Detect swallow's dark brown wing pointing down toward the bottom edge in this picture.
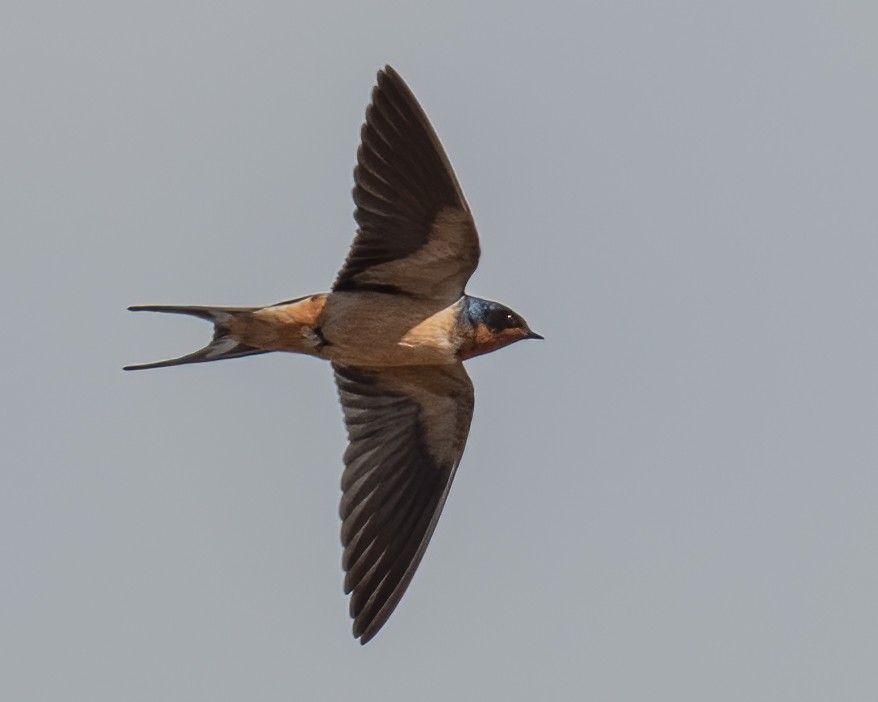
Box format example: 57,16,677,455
333,363,473,643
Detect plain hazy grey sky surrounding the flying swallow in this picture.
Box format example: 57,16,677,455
0,0,878,702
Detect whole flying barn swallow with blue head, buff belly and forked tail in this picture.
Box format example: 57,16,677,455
126,66,543,644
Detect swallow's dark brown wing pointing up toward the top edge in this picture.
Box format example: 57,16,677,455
333,66,479,302
